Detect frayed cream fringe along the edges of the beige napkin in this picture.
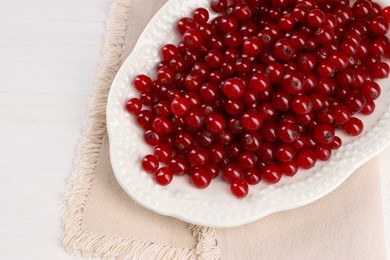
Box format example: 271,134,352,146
62,0,221,259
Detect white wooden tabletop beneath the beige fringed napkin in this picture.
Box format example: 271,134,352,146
0,0,390,260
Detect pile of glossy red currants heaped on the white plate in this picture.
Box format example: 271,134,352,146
126,0,390,198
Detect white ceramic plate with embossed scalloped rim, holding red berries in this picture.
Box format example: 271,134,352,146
107,0,390,227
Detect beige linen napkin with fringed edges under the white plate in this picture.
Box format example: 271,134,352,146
62,0,385,259
